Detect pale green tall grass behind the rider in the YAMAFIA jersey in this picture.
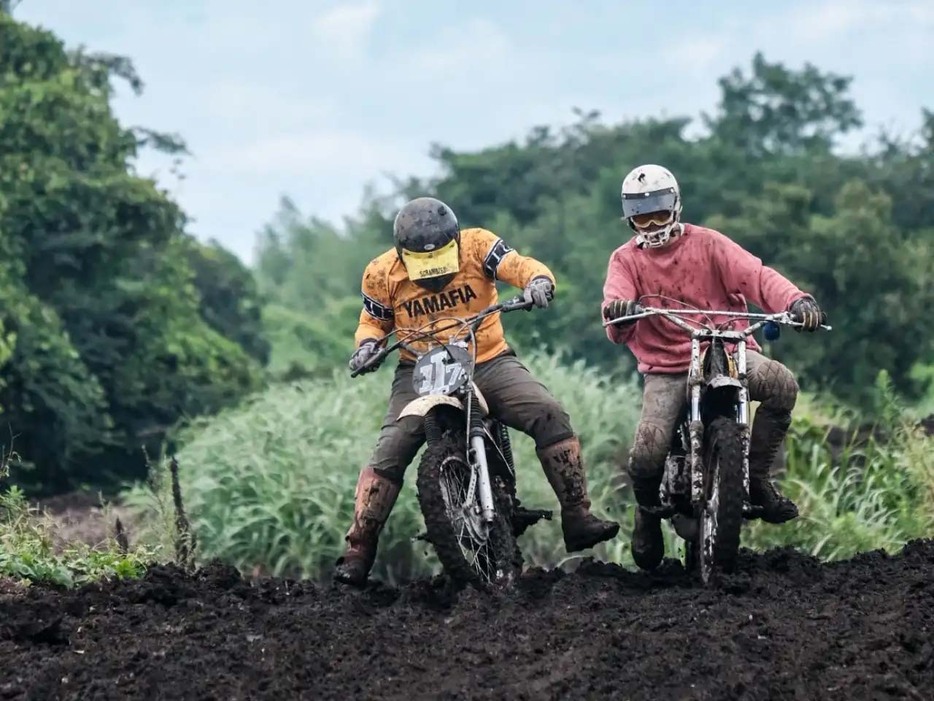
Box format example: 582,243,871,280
128,355,641,581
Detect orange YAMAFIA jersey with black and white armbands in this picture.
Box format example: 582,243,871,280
354,228,555,363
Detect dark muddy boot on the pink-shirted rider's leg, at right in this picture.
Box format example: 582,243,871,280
749,405,798,523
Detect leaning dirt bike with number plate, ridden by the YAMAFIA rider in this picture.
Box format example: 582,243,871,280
351,296,552,589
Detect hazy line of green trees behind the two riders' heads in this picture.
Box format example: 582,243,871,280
257,54,934,410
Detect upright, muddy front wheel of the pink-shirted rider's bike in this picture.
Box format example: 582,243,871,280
688,417,745,584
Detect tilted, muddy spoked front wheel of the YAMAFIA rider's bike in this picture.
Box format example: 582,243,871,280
417,433,522,589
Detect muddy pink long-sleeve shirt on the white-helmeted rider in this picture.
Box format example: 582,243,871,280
601,224,807,374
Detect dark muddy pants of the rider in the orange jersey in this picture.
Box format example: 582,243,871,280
369,351,574,483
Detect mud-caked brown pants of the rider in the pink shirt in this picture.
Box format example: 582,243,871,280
628,350,798,494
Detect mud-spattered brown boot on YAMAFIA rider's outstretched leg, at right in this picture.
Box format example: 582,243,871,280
536,436,619,552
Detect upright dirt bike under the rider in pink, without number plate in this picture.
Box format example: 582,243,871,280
604,304,831,584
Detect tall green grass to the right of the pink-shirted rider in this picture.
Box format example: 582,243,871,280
745,372,934,560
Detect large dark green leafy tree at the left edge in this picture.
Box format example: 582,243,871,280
0,15,260,491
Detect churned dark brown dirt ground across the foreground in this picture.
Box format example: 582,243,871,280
0,541,934,699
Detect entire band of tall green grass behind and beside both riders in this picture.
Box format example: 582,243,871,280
124,355,934,582
